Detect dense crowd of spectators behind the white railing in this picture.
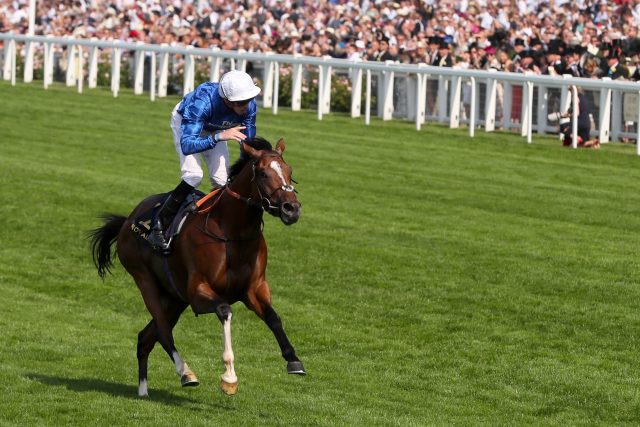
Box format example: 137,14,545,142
0,0,640,80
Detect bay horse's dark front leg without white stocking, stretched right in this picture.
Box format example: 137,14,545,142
244,281,306,375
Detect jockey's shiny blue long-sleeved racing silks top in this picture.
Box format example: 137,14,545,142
178,82,258,156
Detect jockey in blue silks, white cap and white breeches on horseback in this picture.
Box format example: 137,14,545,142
147,70,260,254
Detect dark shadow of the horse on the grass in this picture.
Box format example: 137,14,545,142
25,373,201,406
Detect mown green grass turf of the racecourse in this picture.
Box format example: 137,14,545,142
0,82,640,426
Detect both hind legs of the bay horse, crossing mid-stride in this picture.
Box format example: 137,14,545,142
136,272,198,396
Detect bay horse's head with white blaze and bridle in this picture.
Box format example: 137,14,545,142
243,138,301,225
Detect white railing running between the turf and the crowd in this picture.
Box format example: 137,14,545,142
0,33,640,155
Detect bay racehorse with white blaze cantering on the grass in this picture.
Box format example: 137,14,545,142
89,137,306,396
